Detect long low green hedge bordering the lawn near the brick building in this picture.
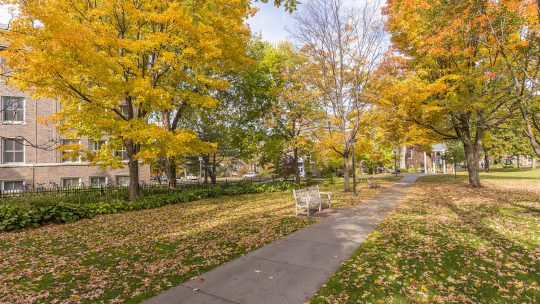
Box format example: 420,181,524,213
0,182,295,231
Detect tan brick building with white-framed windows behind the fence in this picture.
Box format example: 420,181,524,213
0,83,150,191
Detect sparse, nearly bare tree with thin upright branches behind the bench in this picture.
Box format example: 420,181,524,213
292,0,385,191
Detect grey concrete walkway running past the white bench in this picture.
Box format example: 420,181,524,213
144,174,419,304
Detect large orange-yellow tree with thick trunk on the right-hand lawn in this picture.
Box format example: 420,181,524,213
385,0,517,187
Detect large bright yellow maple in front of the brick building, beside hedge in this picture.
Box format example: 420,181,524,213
0,0,251,200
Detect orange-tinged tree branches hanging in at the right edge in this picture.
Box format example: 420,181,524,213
484,0,540,156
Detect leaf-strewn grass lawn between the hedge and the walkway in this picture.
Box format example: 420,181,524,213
0,178,395,303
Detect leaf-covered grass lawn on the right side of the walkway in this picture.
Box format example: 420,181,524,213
312,169,540,303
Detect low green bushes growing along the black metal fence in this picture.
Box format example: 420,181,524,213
0,181,297,231
